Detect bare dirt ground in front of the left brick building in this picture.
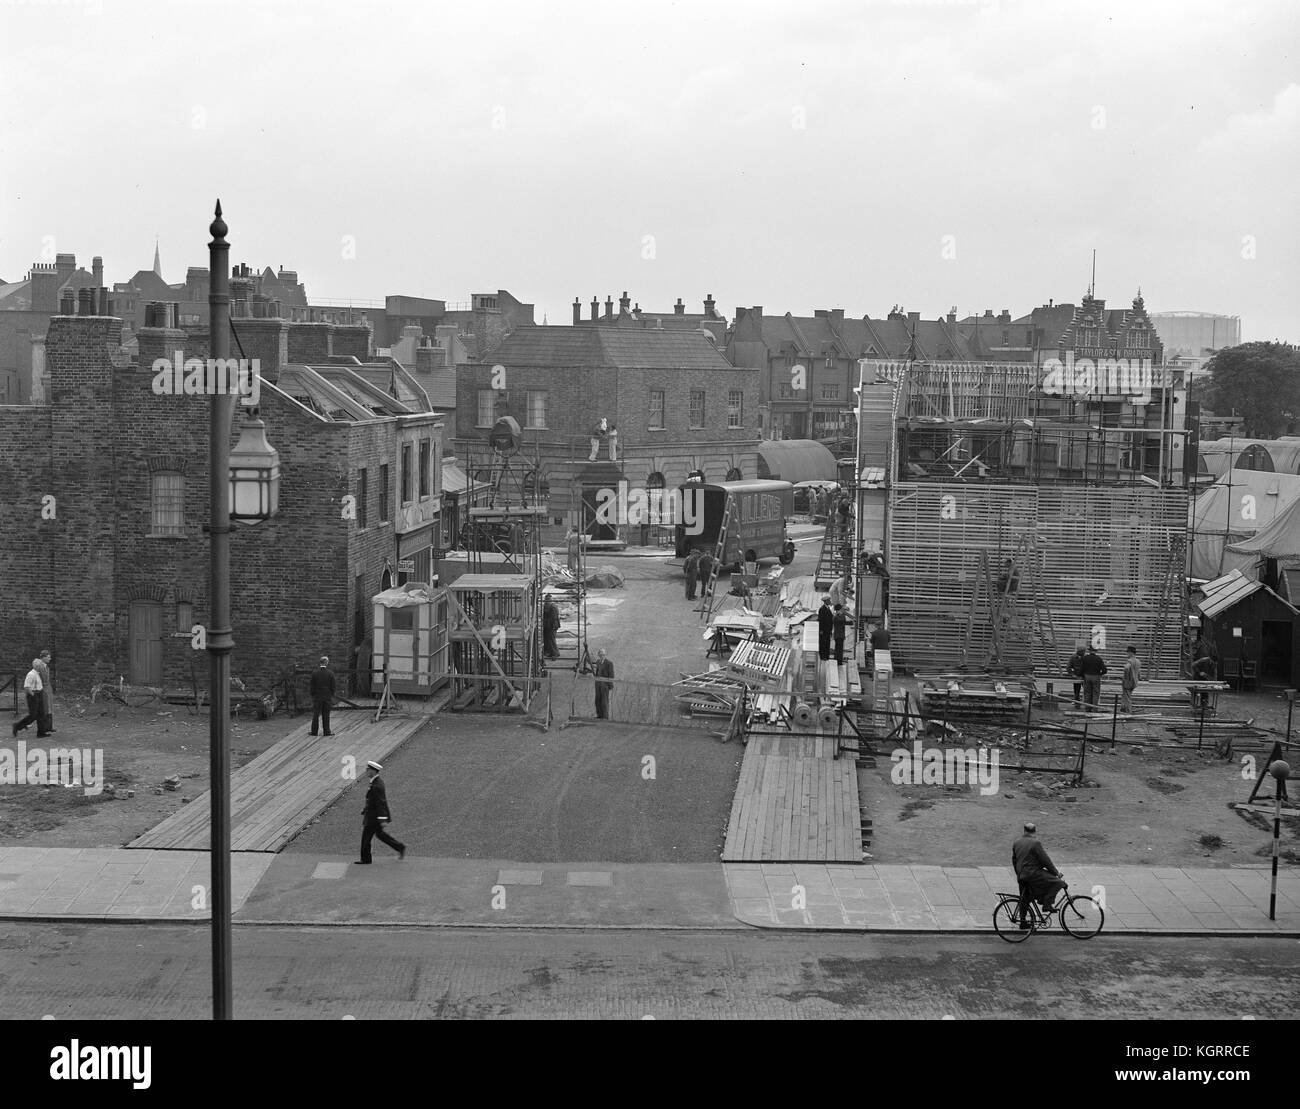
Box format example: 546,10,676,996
0,697,307,848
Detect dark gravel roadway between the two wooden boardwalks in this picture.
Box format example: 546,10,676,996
286,712,742,862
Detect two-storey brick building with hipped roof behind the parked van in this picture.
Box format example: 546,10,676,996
455,326,758,535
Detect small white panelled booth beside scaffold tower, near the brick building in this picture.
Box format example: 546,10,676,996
371,581,450,696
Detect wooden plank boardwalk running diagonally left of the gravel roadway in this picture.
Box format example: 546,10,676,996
127,712,428,852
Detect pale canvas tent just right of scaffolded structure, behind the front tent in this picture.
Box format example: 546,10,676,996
1188,469,1300,580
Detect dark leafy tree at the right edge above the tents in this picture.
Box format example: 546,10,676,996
1206,343,1300,439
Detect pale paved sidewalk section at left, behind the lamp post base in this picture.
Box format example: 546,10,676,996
0,846,276,920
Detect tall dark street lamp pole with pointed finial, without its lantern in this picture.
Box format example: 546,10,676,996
208,200,235,1021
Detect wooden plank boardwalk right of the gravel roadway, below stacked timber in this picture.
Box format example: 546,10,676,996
723,733,862,863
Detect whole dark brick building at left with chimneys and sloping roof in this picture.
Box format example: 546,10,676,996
0,311,442,690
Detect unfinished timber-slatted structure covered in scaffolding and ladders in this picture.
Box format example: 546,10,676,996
855,360,1188,677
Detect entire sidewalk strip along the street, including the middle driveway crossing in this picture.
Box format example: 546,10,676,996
0,846,1300,936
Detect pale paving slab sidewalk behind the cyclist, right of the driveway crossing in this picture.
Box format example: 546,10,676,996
724,861,1300,935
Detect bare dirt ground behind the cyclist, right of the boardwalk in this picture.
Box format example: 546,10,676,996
866,692,1300,867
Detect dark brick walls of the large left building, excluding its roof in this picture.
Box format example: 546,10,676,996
0,317,410,690
